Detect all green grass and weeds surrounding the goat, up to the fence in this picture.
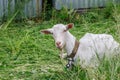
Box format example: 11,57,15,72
0,0,120,80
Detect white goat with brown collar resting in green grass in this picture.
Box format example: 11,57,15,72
41,23,119,68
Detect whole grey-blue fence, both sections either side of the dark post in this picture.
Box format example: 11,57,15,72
0,0,120,21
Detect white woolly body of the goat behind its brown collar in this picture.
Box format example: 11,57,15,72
75,33,119,65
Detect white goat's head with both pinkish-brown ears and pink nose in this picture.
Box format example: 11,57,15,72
41,23,74,49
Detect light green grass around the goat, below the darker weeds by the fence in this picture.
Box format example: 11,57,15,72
0,20,120,80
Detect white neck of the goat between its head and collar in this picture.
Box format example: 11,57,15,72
65,31,76,55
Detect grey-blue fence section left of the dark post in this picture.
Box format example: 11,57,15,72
0,0,42,20
